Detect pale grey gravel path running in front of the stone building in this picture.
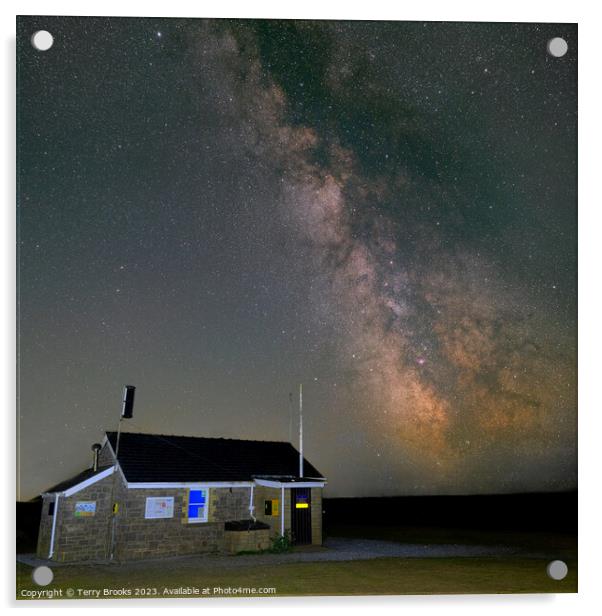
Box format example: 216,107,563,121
17,537,542,569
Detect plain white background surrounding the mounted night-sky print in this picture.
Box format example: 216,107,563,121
0,0,602,616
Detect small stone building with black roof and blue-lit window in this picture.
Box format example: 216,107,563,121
37,432,326,561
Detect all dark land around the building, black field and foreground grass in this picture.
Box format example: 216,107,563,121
17,491,577,596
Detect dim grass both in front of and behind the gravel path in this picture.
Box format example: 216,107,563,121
17,526,577,599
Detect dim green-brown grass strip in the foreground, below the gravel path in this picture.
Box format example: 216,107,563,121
17,558,577,599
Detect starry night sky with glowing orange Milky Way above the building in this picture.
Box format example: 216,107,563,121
17,17,577,499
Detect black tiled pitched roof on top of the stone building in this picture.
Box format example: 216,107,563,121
107,432,322,483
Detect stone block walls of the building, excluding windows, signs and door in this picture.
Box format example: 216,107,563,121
37,458,322,561
